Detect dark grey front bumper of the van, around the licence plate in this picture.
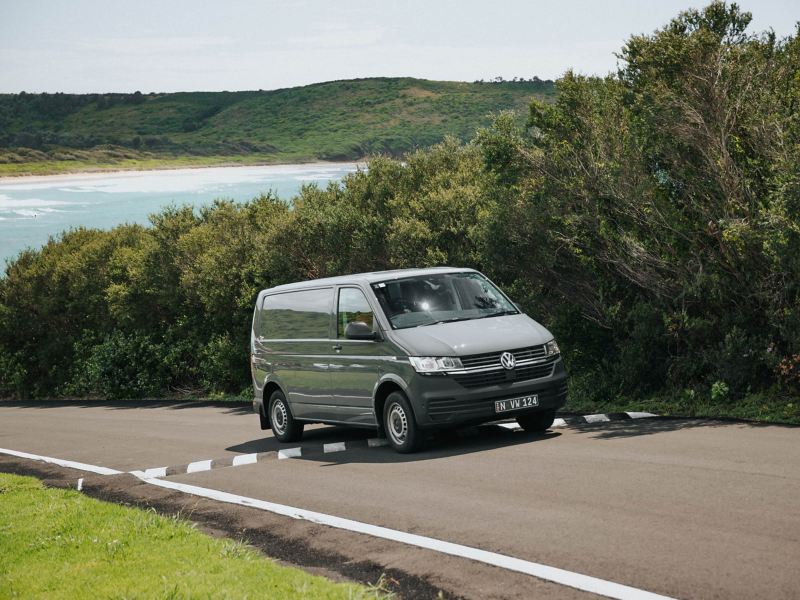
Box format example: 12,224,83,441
409,358,567,428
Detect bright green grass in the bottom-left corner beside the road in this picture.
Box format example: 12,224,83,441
0,473,385,599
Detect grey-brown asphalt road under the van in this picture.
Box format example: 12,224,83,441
0,404,800,599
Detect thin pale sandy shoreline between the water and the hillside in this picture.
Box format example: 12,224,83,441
0,158,368,184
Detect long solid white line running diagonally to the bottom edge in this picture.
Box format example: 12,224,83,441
132,471,668,600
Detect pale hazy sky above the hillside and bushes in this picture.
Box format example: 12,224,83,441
0,0,800,93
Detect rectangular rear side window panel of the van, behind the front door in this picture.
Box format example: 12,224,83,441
259,288,333,340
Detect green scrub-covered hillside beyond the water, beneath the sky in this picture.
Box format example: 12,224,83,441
0,78,555,174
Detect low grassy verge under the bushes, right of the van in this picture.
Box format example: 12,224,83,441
564,386,800,425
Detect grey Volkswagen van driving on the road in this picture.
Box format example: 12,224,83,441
250,267,567,452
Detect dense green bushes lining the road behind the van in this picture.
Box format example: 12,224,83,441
0,3,800,412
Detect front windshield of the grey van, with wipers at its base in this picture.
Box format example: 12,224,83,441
372,273,519,329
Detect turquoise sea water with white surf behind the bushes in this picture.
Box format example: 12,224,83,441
0,163,358,261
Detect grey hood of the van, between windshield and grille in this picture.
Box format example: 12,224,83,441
392,314,553,356
